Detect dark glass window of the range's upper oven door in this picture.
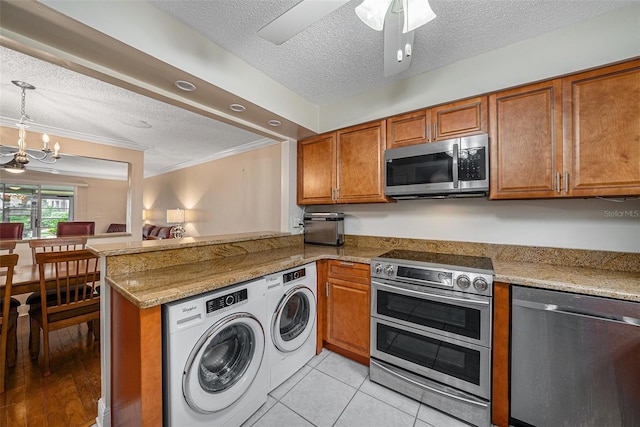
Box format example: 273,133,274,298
377,290,480,340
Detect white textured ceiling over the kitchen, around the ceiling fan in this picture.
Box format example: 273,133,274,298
152,0,634,106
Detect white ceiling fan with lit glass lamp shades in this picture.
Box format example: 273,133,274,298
258,0,436,77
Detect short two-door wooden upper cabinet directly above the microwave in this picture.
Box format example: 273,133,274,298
387,96,488,148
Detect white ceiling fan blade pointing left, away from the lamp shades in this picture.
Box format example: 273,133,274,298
258,0,349,45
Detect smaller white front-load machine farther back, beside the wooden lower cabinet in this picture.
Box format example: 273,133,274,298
265,263,317,391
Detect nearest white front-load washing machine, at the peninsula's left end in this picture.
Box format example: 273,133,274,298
163,278,269,427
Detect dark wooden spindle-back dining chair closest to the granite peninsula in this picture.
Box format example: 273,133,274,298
29,249,100,376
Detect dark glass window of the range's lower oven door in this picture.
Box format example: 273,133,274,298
376,323,480,385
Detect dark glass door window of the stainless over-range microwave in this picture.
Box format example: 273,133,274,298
387,153,453,186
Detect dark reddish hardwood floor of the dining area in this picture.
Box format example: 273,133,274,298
0,316,100,427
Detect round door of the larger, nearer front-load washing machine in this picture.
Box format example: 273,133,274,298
182,313,265,414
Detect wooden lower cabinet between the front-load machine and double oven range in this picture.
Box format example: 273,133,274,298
318,260,371,365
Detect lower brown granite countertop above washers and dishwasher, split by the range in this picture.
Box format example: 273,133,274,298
106,243,640,308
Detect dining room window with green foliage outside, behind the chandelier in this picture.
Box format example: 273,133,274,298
0,184,75,238
